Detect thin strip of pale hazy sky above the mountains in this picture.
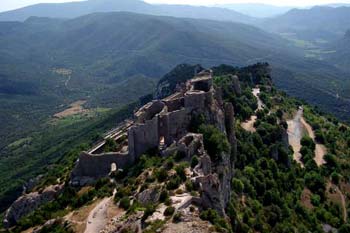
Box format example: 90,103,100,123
0,0,350,11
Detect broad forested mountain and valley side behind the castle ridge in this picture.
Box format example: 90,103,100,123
0,12,350,215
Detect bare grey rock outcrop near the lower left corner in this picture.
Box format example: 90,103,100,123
4,185,63,227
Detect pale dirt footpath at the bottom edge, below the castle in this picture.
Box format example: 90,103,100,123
85,197,112,233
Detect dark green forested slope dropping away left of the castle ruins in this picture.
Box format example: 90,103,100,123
0,103,138,211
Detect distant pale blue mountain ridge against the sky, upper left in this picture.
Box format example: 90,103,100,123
0,0,254,22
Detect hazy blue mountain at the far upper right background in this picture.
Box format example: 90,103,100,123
263,6,350,41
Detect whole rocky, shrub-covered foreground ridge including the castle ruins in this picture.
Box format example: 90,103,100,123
4,63,350,233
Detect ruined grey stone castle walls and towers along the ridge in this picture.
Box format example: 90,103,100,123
71,70,231,186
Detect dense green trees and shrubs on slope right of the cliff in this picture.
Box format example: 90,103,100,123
212,63,350,233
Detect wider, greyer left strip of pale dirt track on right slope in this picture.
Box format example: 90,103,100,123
287,108,304,167
